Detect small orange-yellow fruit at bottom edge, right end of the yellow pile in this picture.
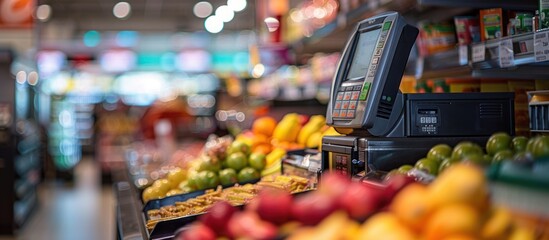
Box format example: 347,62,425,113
481,207,513,239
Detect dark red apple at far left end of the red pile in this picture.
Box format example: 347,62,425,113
200,201,236,235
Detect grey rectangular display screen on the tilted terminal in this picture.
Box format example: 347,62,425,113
346,28,381,80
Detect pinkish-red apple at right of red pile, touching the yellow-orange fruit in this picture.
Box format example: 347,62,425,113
338,182,383,221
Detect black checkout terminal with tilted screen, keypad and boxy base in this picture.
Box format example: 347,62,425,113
322,12,514,176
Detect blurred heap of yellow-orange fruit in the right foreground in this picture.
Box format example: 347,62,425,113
288,164,535,240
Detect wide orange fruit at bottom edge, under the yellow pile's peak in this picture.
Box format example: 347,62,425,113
423,204,481,240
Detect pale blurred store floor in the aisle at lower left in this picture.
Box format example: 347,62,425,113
0,158,116,240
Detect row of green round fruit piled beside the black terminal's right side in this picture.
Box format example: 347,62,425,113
393,132,549,176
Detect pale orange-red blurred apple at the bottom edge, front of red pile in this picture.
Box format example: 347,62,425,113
228,211,277,240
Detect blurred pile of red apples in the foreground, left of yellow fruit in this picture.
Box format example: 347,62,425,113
173,174,413,240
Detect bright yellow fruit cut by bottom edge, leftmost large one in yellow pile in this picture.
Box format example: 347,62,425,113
355,212,416,240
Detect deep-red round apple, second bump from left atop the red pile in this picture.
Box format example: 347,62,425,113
256,188,293,225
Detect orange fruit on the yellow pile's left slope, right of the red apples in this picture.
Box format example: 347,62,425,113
390,183,431,231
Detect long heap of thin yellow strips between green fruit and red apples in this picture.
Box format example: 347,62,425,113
147,175,311,230
